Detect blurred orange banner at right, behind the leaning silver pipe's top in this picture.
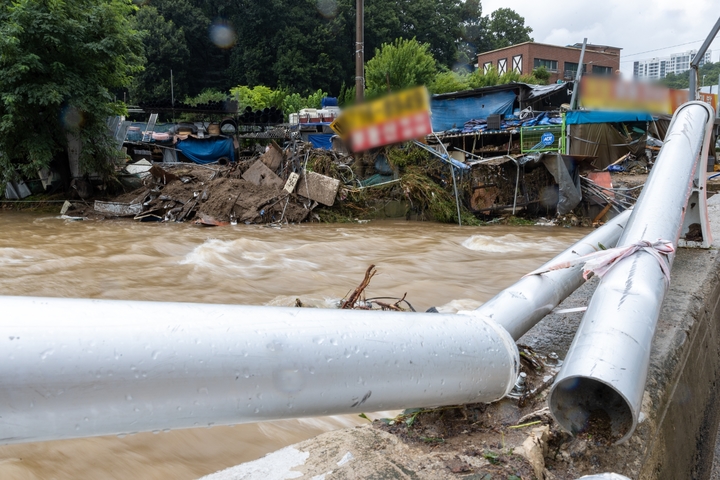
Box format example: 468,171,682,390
580,76,717,115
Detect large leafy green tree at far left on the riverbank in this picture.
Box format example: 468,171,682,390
0,0,142,178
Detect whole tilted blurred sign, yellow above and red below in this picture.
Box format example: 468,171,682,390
330,87,432,152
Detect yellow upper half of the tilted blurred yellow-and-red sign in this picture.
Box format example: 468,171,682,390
330,87,430,138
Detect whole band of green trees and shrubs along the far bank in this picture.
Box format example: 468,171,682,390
0,0,531,180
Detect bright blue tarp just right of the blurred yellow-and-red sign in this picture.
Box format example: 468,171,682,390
430,92,516,132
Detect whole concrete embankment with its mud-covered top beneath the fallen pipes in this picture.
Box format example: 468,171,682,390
206,195,720,480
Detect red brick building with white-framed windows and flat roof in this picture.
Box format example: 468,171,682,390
478,42,621,83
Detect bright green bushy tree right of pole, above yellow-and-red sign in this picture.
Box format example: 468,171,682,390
365,38,436,97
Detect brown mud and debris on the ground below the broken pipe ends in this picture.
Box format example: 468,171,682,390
373,348,640,480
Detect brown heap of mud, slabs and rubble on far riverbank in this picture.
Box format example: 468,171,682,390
66,144,340,226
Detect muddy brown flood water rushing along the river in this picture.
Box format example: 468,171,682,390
0,212,588,480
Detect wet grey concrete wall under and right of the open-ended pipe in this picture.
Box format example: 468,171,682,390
518,195,720,479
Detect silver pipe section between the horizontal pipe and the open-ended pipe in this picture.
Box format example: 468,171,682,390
466,210,630,340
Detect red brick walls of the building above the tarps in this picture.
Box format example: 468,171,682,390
478,43,620,83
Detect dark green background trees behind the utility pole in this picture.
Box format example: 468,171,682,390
130,0,532,102
